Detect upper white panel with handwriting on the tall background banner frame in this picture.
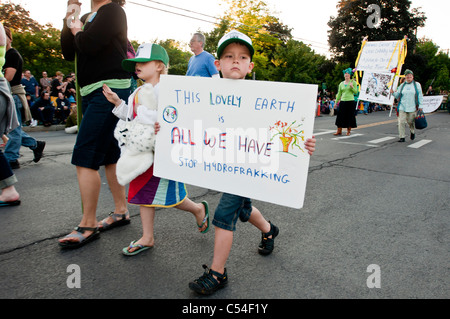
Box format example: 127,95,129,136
356,41,403,73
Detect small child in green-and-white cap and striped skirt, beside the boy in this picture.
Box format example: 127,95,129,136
104,43,209,256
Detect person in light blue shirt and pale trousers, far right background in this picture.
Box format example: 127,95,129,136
391,70,423,142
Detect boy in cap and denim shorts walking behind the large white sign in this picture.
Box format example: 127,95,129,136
189,30,316,294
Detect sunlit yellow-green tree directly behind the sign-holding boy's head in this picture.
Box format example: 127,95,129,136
198,0,334,84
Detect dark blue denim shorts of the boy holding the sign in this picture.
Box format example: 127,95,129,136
212,193,252,231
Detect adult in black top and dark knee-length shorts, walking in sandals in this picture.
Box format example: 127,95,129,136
59,0,130,248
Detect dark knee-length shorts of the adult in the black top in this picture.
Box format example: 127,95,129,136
72,88,130,170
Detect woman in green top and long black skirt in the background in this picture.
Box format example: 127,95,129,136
334,68,358,136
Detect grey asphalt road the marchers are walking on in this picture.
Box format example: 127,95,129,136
0,111,450,308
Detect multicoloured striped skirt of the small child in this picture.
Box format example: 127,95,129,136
128,165,187,207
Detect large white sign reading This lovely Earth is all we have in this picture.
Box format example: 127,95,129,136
154,75,318,208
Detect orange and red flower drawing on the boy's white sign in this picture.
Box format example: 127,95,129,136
269,121,305,156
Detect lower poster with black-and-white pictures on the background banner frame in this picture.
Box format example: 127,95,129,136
359,72,398,105
